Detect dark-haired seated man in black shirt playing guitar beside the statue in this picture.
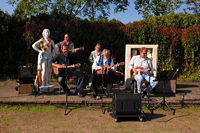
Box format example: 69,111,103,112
52,43,84,97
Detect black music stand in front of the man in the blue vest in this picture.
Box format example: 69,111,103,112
94,72,116,113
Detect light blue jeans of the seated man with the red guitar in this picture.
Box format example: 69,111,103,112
134,72,158,93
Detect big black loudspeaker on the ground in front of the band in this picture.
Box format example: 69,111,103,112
112,93,142,115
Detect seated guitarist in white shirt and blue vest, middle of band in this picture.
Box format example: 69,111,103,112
92,49,119,98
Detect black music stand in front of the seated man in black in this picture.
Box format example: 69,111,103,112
58,67,75,115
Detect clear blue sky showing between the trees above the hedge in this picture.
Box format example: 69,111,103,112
0,0,188,24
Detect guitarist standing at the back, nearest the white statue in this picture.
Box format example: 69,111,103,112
56,34,84,53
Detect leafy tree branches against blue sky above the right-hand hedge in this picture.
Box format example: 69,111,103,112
134,0,182,18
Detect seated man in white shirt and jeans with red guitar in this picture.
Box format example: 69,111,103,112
129,47,158,97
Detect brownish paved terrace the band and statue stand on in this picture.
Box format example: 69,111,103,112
0,80,200,106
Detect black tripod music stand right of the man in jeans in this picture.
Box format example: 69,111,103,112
152,70,180,115
